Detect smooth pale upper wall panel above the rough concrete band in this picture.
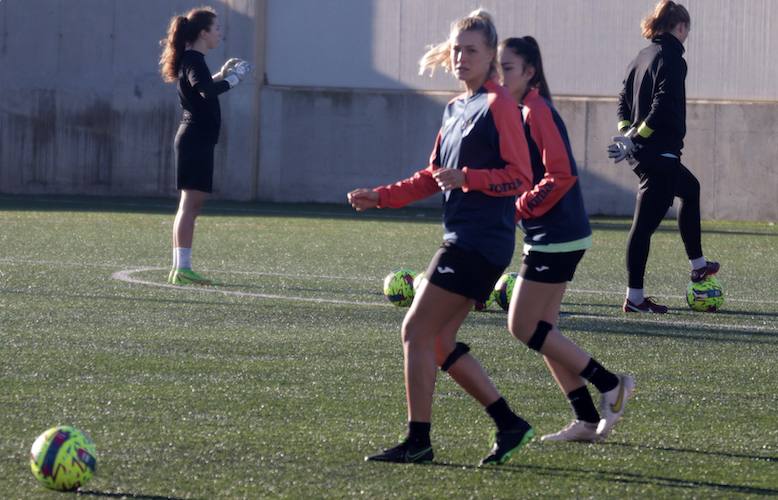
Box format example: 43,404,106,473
267,0,778,100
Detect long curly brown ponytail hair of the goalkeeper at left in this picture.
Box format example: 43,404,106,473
159,7,216,82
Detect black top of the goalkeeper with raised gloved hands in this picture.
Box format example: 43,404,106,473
178,50,230,144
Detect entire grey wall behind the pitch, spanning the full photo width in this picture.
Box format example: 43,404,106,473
0,0,778,220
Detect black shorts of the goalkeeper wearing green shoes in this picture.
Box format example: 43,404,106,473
175,123,216,193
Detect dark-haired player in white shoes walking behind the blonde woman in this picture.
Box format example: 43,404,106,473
499,36,635,441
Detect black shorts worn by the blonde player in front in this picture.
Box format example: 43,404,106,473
425,243,505,302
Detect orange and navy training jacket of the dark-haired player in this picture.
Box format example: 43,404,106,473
516,89,592,253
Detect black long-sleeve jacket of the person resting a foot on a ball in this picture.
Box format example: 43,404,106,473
618,33,687,160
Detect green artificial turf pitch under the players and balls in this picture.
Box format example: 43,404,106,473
0,196,778,498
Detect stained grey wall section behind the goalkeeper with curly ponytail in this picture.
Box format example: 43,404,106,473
0,0,264,199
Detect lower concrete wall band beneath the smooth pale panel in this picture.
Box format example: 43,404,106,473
259,87,778,220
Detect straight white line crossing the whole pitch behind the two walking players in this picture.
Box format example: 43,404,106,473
0,257,778,305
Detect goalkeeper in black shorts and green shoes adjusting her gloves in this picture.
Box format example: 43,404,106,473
160,7,250,285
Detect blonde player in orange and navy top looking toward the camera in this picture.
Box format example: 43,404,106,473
348,11,534,465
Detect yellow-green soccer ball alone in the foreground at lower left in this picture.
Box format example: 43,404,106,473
30,425,97,491
